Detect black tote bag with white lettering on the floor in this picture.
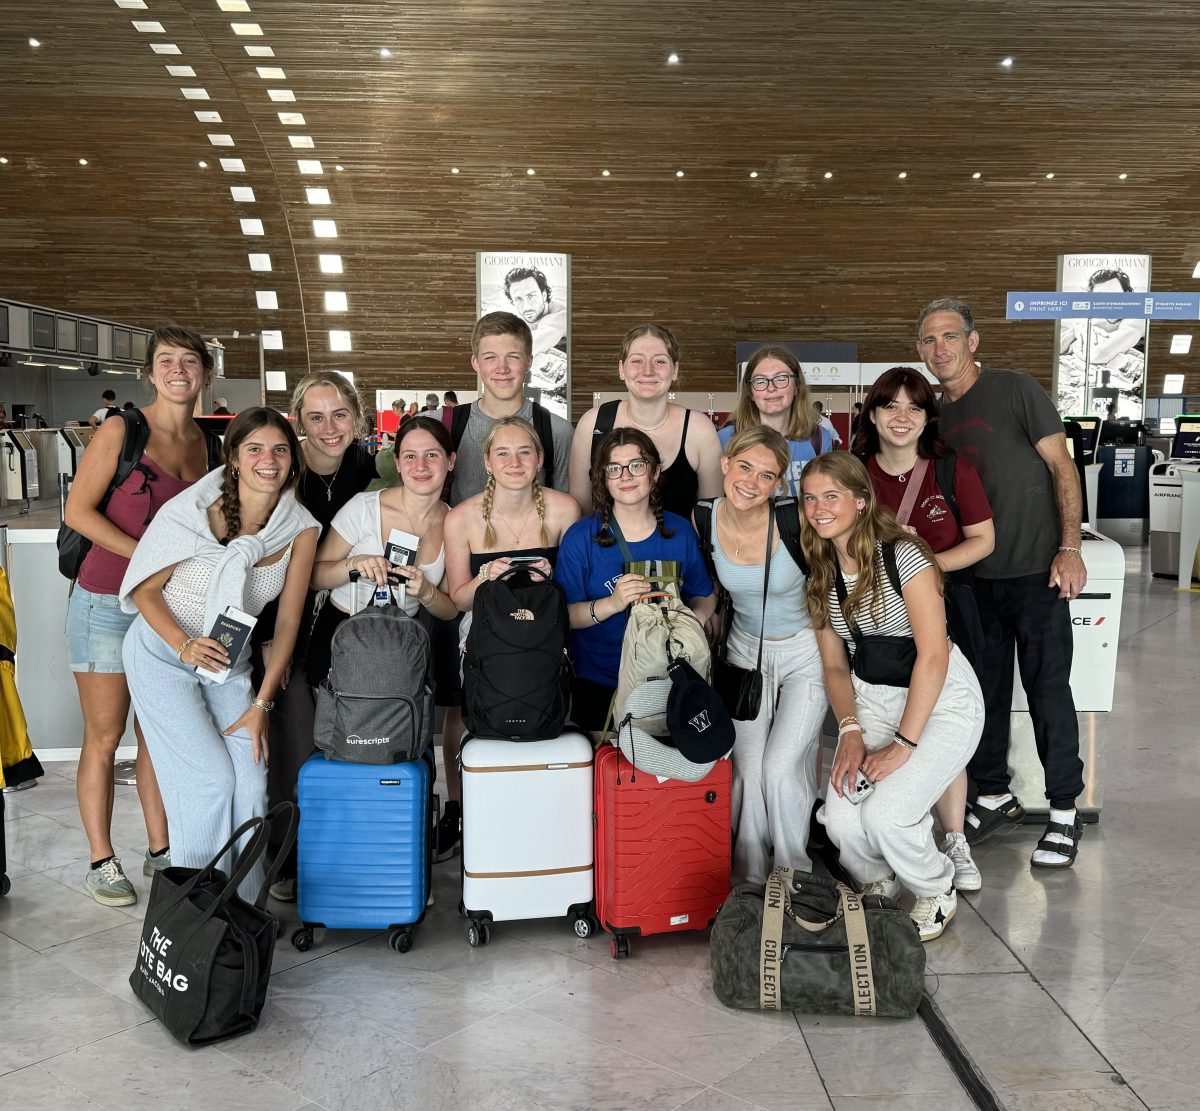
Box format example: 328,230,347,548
130,803,299,1045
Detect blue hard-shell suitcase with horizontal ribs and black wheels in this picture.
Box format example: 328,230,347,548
292,752,434,953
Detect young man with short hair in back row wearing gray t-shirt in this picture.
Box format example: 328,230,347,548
450,312,575,505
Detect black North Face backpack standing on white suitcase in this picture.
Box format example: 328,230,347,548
462,567,571,740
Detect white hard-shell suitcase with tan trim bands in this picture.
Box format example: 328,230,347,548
461,733,599,945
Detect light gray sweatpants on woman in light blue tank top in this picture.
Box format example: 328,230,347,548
726,629,827,883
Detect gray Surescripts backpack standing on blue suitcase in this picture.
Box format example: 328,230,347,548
313,605,433,764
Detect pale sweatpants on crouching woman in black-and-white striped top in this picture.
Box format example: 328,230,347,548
825,647,983,895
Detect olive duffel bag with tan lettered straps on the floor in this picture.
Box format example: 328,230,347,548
712,869,925,1019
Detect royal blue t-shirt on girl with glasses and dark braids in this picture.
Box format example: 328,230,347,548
554,514,713,686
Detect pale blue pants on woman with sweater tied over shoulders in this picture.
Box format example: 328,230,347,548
122,615,266,900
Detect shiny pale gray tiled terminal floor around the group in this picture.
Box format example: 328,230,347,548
0,552,1200,1111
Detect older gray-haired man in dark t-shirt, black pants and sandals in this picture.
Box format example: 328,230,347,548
917,298,1087,867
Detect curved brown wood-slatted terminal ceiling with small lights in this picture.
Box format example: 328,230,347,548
0,0,1200,413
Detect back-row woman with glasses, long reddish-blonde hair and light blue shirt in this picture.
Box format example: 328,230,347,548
718,344,833,498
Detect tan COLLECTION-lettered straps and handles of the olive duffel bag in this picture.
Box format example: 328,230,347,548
758,867,875,1015
